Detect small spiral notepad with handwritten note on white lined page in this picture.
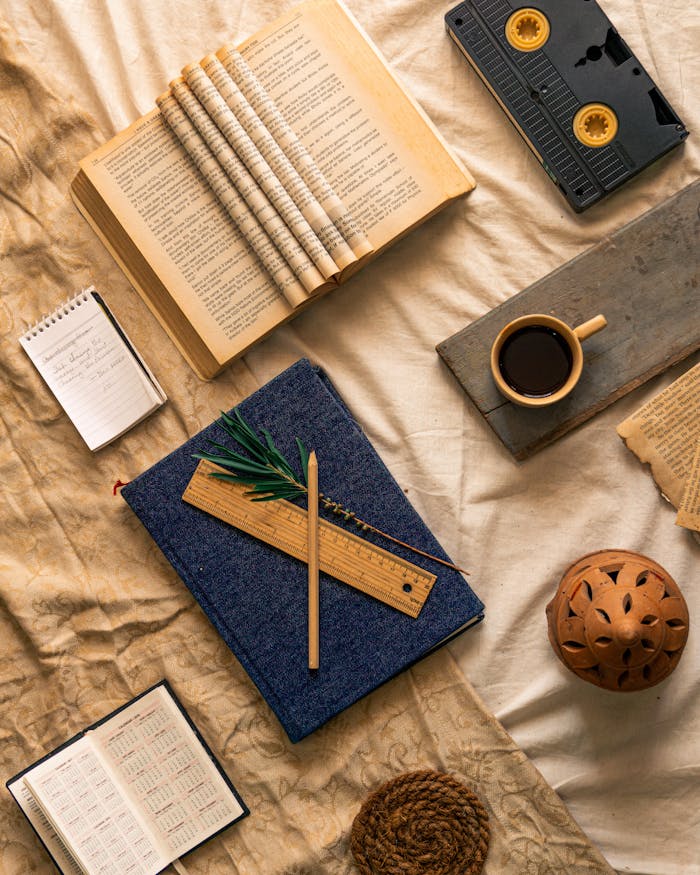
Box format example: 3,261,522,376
19,287,166,451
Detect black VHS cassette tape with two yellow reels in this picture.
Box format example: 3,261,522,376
445,0,688,212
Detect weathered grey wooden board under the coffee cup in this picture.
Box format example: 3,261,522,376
437,181,700,459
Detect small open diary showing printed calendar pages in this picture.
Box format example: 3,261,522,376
7,681,249,875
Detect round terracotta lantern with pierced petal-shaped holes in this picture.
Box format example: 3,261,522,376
547,550,688,691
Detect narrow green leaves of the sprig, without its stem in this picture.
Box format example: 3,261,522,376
193,408,309,501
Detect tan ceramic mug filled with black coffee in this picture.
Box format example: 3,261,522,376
491,313,608,407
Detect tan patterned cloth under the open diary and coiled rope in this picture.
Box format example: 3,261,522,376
0,29,612,875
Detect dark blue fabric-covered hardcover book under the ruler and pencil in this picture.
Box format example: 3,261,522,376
122,359,483,741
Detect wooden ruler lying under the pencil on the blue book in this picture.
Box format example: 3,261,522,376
182,460,436,617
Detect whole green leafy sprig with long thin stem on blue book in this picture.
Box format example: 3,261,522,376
193,408,468,574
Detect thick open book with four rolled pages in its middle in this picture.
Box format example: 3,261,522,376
71,0,474,378
